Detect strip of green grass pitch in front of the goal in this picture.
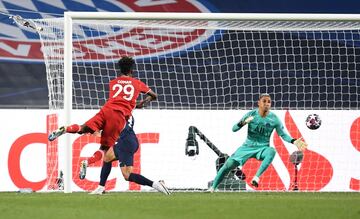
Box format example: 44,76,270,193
0,192,360,219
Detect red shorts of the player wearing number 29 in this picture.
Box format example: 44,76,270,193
85,107,126,147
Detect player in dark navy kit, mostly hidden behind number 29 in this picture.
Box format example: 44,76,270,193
90,117,170,195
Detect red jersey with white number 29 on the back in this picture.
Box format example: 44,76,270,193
104,75,150,116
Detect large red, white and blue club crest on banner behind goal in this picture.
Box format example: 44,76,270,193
0,0,214,62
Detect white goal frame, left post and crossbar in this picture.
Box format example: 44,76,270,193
62,12,360,193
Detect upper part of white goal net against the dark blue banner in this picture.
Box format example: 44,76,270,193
34,19,359,109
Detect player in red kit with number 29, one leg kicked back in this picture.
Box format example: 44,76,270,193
48,56,157,179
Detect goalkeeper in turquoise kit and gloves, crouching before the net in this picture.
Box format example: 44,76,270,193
208,93,307,192
